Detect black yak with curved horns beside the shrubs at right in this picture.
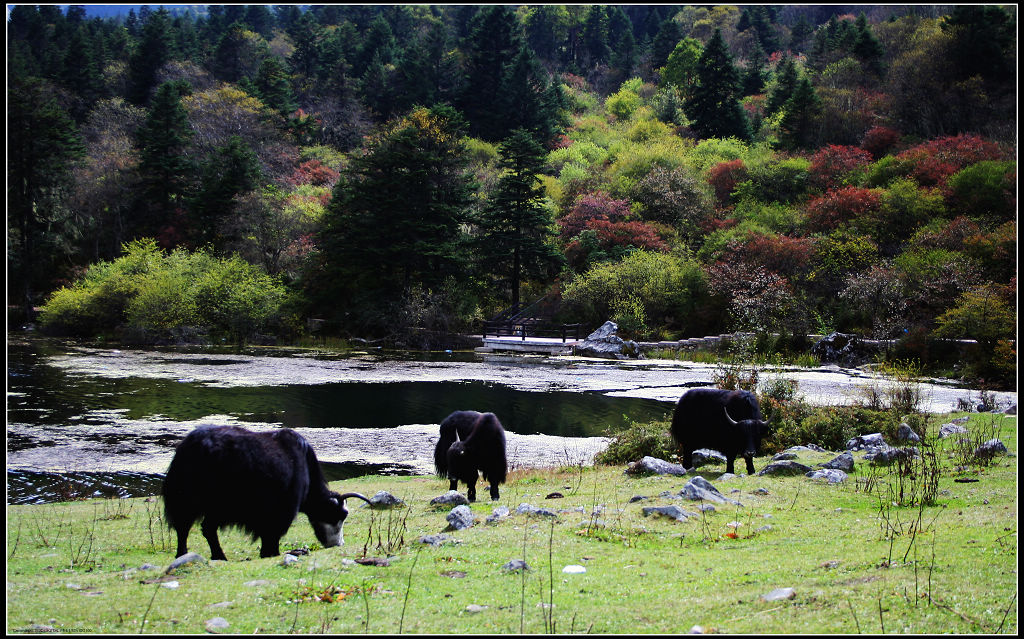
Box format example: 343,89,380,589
672,388,768,475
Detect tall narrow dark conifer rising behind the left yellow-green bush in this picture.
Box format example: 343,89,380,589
136,82,195,236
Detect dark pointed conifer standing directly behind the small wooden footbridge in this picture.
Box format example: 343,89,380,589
475,129,563,306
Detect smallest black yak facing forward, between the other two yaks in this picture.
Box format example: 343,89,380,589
434,411,508,502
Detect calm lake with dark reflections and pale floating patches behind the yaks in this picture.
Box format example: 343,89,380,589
7,334,1017,503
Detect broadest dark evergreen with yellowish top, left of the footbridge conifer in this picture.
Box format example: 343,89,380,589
311,108,473,313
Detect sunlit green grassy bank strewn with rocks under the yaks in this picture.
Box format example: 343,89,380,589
7,415,1018,634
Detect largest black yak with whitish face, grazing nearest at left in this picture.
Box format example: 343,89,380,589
157,426,370,559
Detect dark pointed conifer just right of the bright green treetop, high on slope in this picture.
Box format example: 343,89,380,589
685,29,751,140
